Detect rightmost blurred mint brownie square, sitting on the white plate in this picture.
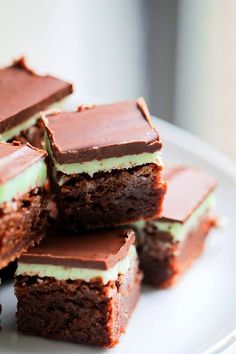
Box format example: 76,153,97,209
134,167,216,288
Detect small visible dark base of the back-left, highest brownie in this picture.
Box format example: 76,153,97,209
8,119,44,149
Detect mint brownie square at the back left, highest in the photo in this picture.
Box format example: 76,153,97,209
0,58,72,147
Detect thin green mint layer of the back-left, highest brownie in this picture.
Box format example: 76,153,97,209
0,99,64,142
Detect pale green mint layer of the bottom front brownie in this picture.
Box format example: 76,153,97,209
16,246,137,284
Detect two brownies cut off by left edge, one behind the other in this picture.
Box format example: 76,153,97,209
0,58,72,326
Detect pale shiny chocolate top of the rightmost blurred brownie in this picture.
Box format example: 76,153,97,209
159,167,216,223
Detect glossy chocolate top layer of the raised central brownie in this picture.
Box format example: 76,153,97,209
44,98,162,164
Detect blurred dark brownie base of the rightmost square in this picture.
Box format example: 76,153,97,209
138,215,215,288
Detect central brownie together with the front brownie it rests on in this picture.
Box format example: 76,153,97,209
15,99,166,347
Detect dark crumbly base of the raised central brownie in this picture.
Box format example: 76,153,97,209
55,164,166,232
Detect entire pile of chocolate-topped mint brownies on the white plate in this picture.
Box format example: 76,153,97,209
0,60,218,348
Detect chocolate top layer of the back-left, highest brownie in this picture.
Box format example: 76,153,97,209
0,58,72,133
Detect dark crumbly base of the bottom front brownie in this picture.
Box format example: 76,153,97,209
15,264,141,348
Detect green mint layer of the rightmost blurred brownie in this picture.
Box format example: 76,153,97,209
134,192,215,241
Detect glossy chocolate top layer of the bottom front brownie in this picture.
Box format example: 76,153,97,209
19,229,135,270
